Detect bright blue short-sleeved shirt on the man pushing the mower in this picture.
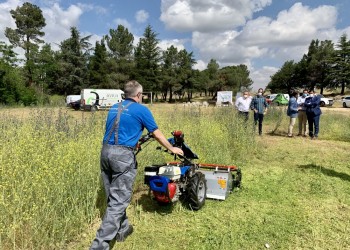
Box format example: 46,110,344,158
103,99,158,147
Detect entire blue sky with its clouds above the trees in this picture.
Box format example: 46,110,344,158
0,0,350,90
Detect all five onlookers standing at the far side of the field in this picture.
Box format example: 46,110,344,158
235,88,322,139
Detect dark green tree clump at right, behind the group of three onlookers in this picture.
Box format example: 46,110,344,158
267,34,350,95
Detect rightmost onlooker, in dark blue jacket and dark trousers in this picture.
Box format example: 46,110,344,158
304,90,322,139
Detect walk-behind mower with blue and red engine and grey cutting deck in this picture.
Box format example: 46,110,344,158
136,130,242,210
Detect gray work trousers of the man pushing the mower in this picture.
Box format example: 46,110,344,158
90,145,137,250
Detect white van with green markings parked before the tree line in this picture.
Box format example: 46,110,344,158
80,89,124,111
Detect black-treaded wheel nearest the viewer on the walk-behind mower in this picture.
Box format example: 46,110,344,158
186,172,207,210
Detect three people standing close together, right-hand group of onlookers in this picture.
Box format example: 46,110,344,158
287,89,322,139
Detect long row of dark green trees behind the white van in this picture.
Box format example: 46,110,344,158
0,2,253,105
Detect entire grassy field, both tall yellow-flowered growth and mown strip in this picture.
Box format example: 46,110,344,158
0,105,350,250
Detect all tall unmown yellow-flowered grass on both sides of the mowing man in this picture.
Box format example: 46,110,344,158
0,105,254,249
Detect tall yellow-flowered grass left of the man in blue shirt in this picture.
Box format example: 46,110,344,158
0,109,103,249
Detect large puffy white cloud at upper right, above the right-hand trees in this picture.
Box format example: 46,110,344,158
237,3,337,47
